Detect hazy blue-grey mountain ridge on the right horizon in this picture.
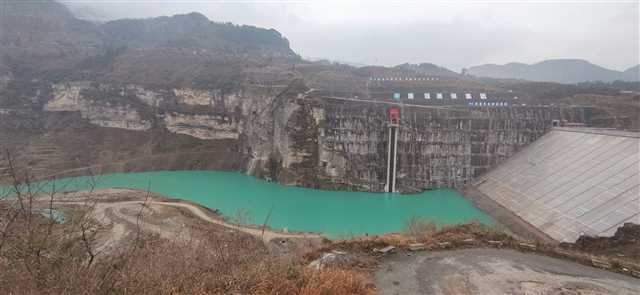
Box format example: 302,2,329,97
468,59,639,83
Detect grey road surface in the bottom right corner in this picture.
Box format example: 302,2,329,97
375,249,640,295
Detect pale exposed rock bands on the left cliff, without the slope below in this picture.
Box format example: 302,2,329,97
44,82,251,140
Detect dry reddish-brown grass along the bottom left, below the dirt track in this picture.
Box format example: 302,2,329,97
0,204,374,295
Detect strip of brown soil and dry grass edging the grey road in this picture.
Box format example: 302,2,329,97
306,223,640,278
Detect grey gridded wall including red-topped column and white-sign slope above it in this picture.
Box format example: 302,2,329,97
290,78,598,192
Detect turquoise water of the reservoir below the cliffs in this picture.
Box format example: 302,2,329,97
3,171,493,238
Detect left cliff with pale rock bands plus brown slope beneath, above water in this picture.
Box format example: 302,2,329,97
0,81,264,181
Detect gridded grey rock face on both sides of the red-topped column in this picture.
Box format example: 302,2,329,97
304,100,552,192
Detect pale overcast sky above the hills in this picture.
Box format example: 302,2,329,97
63,0,640,71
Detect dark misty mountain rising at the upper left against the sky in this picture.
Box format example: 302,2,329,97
0,0,299,86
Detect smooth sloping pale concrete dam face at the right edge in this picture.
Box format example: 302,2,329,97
478,128,640,242
